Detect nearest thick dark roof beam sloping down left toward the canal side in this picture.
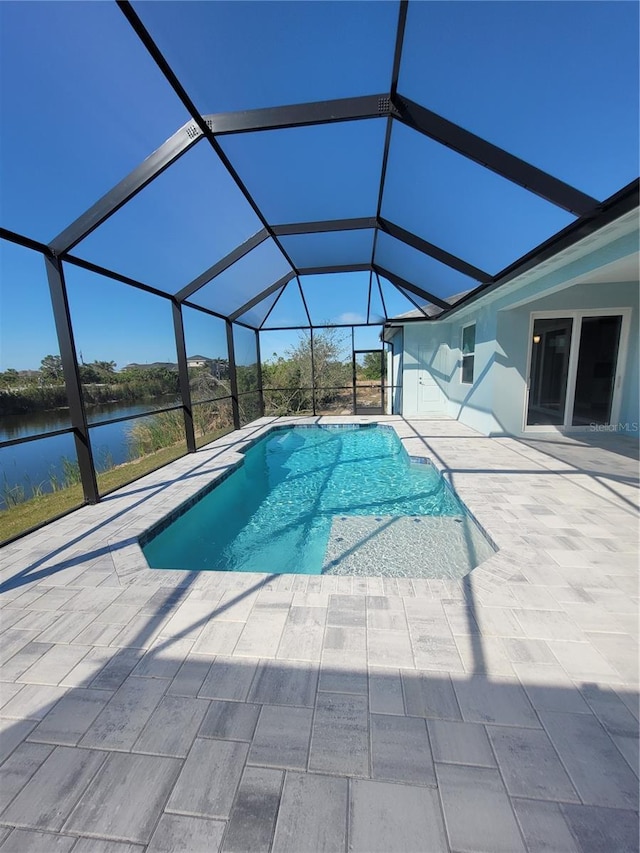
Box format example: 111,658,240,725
49,120,202,255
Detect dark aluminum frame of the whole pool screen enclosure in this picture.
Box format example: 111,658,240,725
0,0,640,532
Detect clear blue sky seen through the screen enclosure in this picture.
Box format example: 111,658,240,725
0,0,638,369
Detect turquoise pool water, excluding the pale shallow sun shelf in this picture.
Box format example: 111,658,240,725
143,427,464,574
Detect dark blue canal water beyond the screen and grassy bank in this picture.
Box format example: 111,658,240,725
0,396,175,509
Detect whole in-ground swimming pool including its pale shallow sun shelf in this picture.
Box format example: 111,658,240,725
141,425,494,577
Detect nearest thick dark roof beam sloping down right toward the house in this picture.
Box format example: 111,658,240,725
394,96,599,216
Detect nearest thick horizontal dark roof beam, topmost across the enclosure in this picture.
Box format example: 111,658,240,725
203,94,390,136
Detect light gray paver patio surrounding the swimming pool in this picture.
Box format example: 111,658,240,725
0,417,639,853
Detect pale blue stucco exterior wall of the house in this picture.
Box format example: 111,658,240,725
402,221,640,435
